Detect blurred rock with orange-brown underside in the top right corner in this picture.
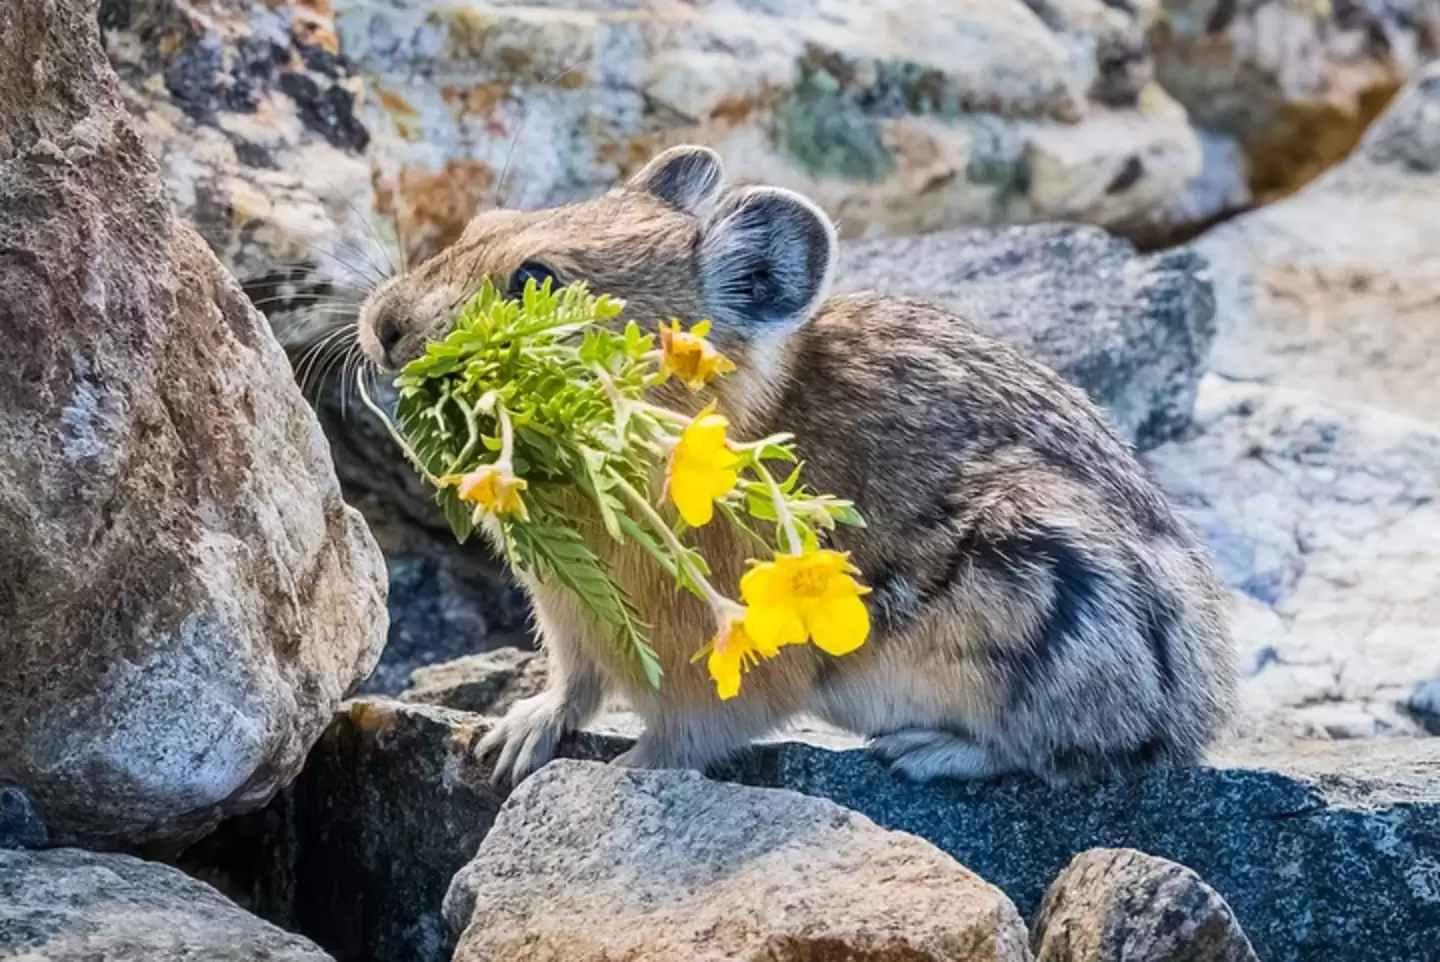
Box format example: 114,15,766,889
1149,0,1440,202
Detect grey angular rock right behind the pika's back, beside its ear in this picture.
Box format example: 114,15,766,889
837,225,1214,448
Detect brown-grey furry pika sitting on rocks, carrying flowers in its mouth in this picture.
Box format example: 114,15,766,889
359,147,1236,782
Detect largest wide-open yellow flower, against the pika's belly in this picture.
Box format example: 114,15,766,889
740,550,870,655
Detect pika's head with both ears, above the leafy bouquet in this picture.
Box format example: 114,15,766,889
359,147,835,385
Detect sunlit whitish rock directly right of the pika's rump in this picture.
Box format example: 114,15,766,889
1148,377,1440,737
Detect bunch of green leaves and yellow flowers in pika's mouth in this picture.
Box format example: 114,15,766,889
360,281,870,698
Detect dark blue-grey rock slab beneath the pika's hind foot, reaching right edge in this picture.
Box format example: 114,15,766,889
769,740,1440,962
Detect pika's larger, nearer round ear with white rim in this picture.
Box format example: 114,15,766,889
700,187,837,331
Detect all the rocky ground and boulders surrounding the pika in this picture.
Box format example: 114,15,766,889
0,0,1440,962
